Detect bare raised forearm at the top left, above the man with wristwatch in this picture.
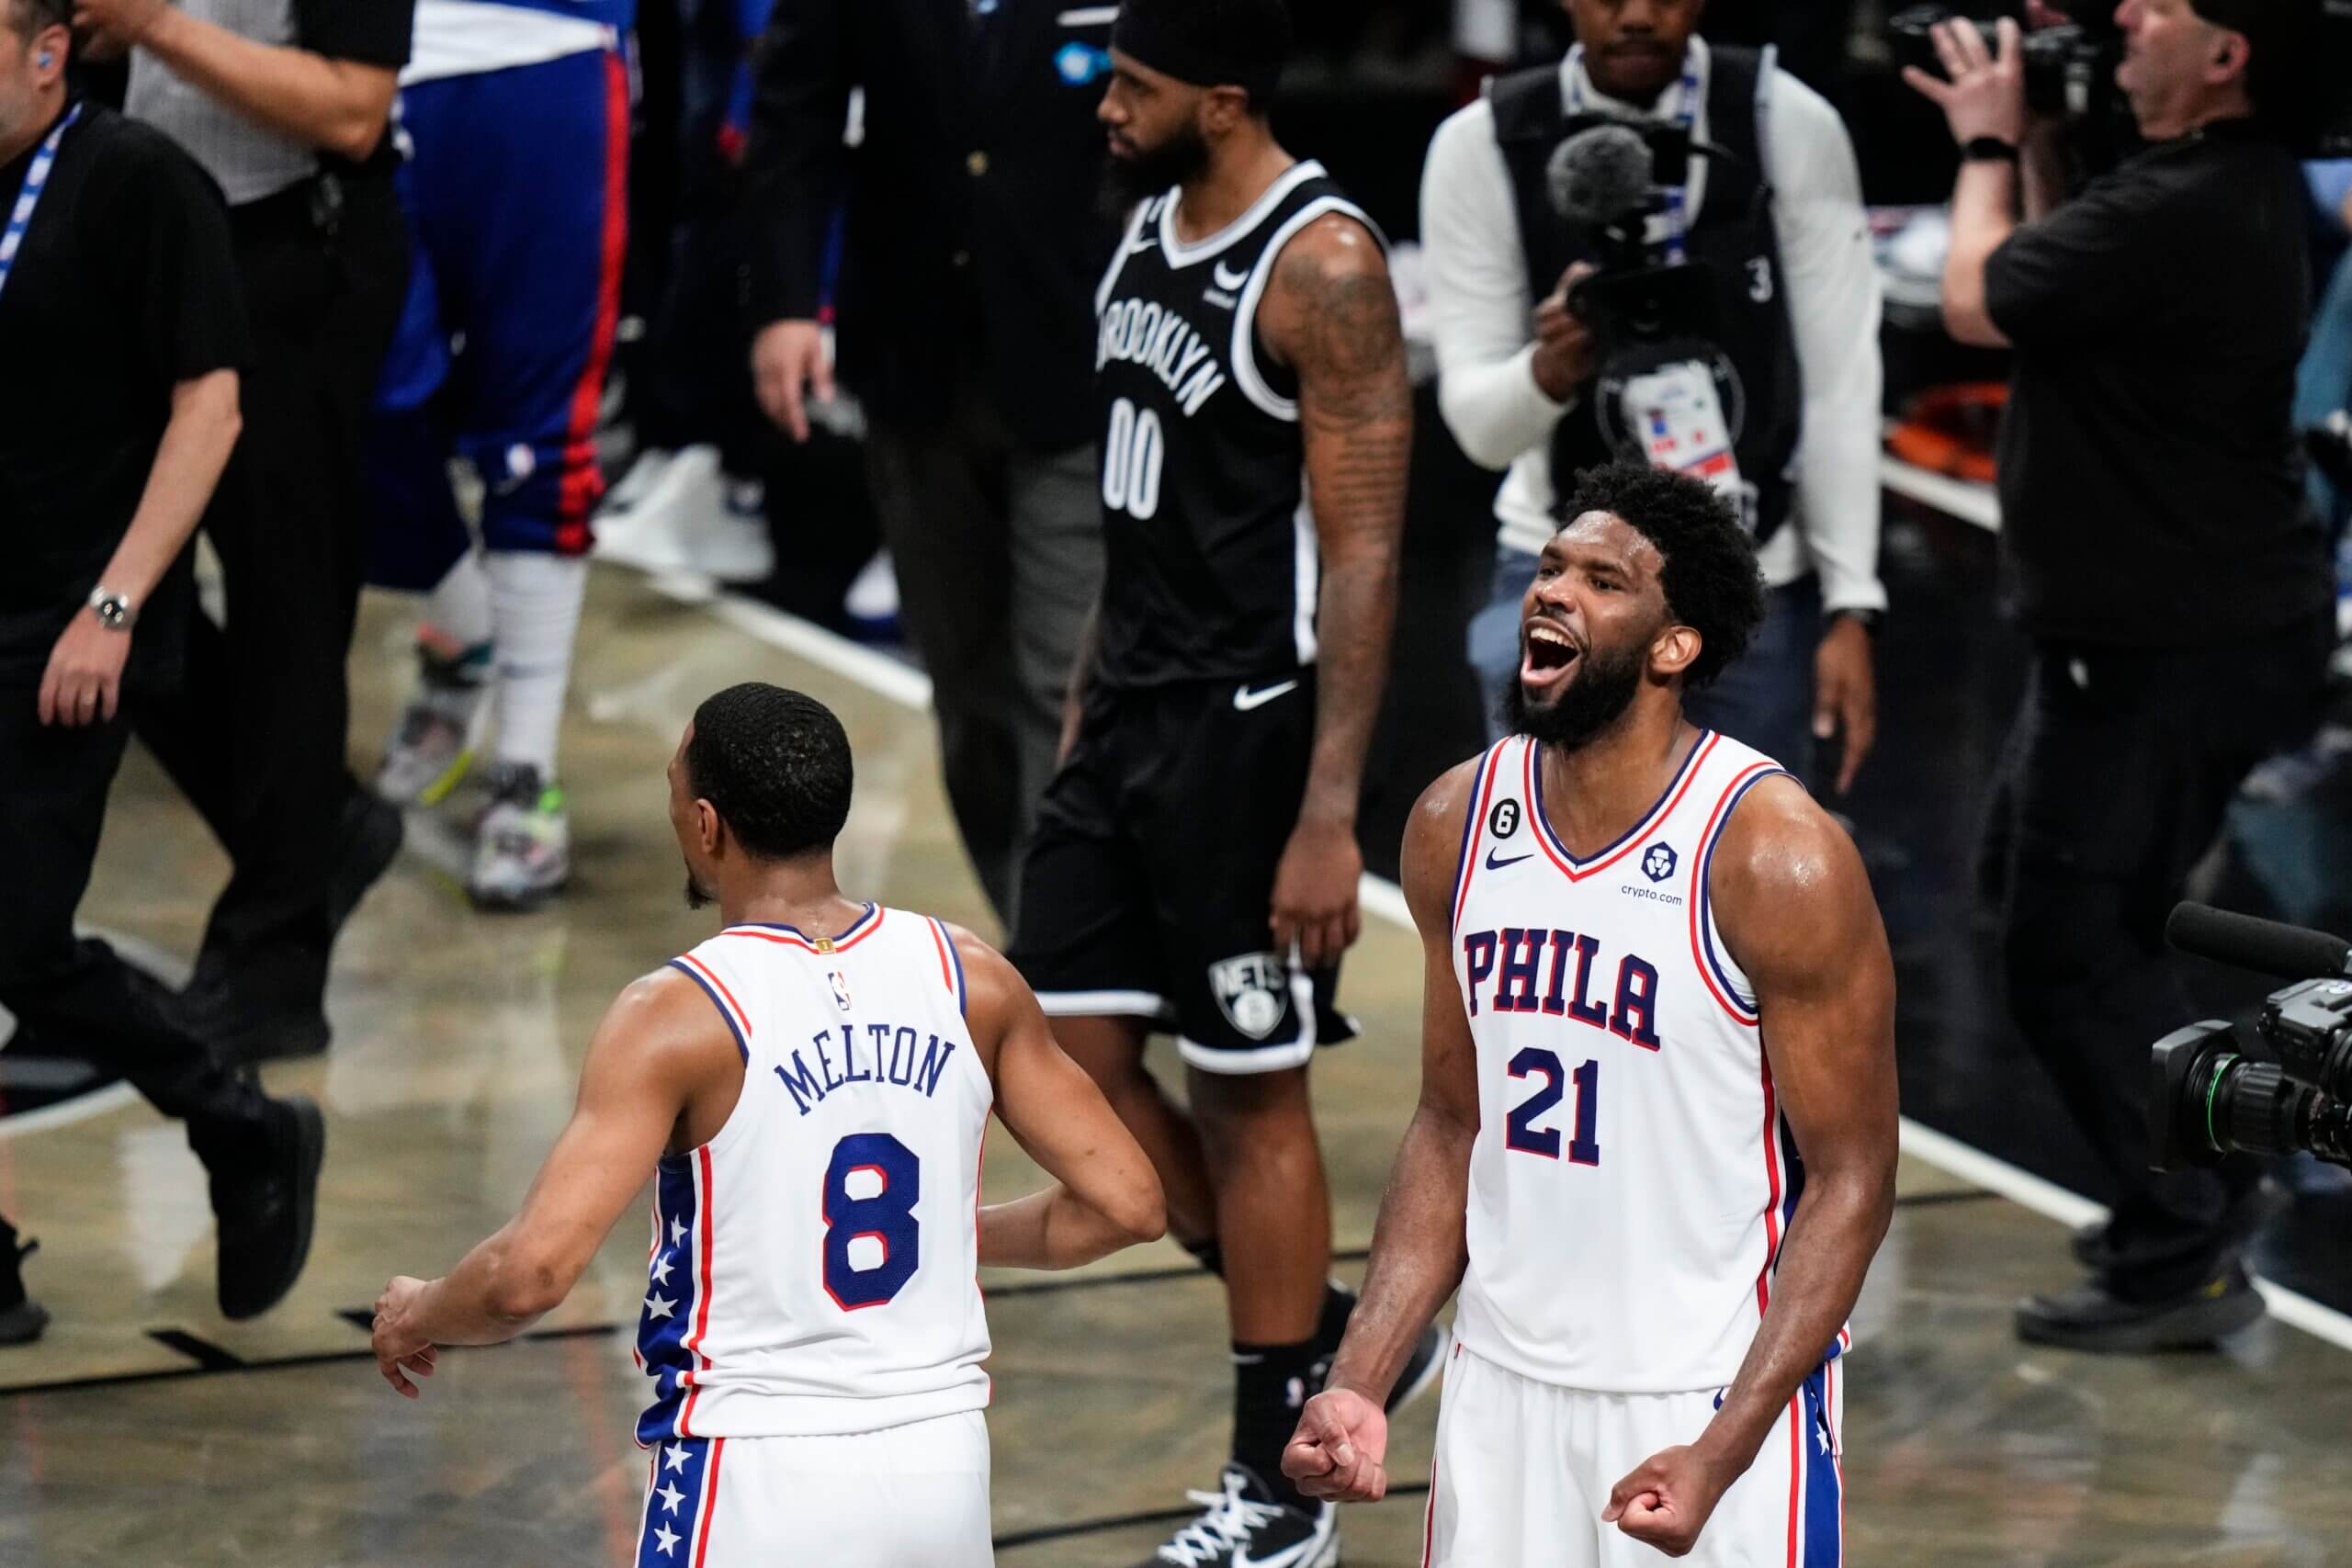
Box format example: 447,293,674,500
139,5,398,160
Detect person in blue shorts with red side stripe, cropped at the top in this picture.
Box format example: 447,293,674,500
371,0,630,909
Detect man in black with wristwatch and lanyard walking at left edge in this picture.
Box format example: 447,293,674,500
0,0,324,1342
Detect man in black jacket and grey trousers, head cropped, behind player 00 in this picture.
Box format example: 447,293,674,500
746,0,1117,926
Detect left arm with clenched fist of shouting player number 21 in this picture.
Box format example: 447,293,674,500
1282,761,1479,1502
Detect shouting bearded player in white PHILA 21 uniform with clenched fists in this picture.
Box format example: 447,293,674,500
1284,466,1895,1568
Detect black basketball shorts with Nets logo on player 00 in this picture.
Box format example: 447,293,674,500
1012,670,1355,1075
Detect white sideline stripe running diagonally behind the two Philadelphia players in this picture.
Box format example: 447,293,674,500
635,570,2352,1349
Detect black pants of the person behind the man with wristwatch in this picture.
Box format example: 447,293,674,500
131,179,409,1010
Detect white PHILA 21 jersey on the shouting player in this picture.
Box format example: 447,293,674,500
1453,731,1849,1394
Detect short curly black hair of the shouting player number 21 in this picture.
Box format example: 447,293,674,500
1559,463,1764,691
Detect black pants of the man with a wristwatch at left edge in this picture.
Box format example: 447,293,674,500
0,682,264,1170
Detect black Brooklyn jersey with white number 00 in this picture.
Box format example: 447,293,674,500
1093,163,1378,686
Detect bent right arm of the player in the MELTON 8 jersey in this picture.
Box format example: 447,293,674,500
955,931,1167,1269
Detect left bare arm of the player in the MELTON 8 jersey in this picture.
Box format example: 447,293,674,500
377,968,741,1392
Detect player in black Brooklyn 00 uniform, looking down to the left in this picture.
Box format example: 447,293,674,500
1012,0,1437,1568
